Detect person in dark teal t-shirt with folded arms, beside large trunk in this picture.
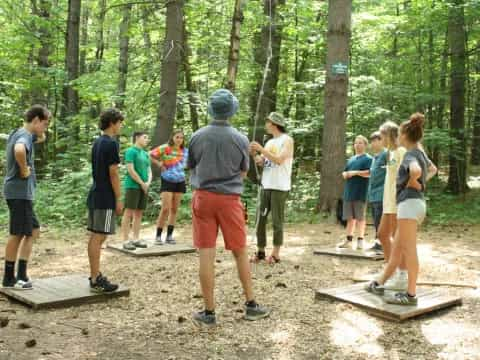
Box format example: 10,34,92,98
338,135,372,250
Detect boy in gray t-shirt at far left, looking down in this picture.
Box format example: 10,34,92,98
2,105,51,290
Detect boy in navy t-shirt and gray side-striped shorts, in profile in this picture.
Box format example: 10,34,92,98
87,109,123,293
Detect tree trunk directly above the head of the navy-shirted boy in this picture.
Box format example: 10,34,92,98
115,4,132,109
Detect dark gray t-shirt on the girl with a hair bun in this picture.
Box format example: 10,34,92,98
397,149,432,204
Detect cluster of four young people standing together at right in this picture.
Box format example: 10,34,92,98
338,113,437,305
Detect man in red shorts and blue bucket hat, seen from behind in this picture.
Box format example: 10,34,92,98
188,89,270,326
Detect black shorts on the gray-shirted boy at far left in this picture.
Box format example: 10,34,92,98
7,199,40,236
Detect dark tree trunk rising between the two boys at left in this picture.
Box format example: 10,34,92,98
61,0,82,119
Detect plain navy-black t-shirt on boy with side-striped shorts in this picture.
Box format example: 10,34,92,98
87,135,120,209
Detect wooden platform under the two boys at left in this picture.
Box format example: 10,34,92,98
0,275,130,310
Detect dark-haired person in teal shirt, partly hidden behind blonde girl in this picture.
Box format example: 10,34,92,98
368,131,387,253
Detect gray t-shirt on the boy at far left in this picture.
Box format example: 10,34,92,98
3,128,36,201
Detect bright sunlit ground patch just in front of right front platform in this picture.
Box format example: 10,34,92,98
330,306,384,356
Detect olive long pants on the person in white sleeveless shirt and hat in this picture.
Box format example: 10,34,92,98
257,189,288,249
